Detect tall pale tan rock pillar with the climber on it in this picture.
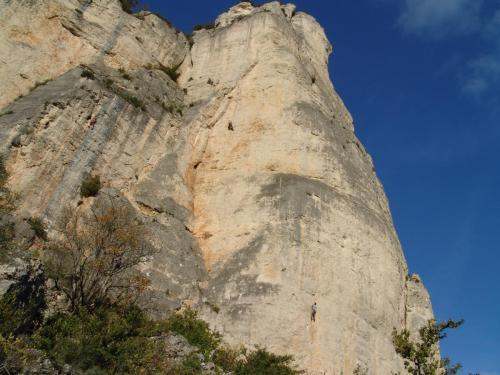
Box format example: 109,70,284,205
179,4,431,374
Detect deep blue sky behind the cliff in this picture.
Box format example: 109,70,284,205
138,0,500,375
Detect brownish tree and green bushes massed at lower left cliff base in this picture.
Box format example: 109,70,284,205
0,191,303,375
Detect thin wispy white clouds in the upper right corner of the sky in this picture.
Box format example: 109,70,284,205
384,0,500,99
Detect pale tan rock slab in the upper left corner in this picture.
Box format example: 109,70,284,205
0,0,188,108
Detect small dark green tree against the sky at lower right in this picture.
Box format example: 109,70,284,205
392,319,463,375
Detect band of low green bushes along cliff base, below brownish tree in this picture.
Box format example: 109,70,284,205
0,296,303,375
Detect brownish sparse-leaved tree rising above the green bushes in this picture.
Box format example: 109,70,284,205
46,196,153,311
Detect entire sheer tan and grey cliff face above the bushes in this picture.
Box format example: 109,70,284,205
0,0,432,374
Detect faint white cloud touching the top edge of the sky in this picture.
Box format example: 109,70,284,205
398,0,483,39
